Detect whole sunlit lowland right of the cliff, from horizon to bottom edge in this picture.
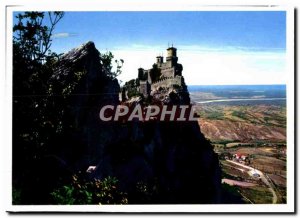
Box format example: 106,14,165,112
189,85,286,204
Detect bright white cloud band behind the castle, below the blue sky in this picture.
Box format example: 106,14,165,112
108,45,287,85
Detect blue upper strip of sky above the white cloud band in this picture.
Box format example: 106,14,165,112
51,11,286,49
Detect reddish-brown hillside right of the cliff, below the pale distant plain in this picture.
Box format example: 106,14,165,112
197,104,286,142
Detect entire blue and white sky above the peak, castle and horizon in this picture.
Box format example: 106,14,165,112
15,11,287,85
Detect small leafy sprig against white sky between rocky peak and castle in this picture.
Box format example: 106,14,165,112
100,51,124,79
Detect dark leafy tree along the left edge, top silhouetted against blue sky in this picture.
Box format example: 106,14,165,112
13,12,64,204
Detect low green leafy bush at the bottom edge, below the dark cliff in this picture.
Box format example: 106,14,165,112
51,175,128,205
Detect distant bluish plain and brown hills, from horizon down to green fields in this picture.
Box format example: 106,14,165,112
190,86,286,142
